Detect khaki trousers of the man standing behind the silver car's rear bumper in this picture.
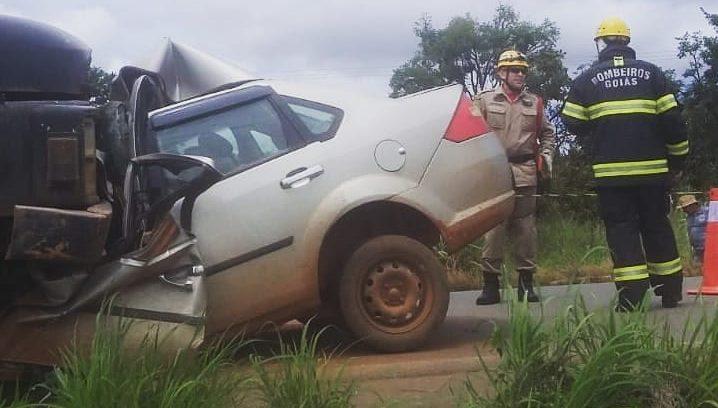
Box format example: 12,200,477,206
481,186,536,274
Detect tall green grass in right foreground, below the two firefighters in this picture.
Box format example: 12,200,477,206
460,298,718,408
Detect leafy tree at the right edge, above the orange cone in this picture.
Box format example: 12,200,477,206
677,9,718,189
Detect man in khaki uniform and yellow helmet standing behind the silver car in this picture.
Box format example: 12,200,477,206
473,50,555,305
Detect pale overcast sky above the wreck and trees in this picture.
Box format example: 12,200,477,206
0,0,718,94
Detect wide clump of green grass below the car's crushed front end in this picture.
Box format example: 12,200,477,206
47,314,247,408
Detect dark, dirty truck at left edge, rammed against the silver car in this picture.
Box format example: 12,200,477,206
0,16,112,305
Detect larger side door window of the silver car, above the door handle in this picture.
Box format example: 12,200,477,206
156,99,288,174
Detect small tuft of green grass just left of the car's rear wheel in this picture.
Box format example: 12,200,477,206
251,324,356,408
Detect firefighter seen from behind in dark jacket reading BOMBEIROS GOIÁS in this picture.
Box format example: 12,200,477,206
561,17,688,311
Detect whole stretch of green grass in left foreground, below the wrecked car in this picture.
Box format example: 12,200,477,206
0,314,356,408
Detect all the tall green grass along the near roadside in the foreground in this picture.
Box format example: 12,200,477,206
5,295,718,408
